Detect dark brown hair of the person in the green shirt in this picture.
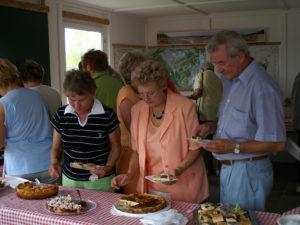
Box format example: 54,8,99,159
81,49,108,72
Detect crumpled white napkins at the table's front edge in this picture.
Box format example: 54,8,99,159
140,209,188,225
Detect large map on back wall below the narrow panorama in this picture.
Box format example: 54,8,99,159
113,44,280,92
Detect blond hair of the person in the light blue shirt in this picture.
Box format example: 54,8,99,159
0,58,23,88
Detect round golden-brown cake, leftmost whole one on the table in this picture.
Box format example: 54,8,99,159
16,182,58,199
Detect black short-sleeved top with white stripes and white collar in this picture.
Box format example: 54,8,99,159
51,99,119,181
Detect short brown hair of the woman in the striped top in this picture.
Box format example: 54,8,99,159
64,70,96,95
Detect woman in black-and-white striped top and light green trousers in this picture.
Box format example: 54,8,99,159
49,70,121,191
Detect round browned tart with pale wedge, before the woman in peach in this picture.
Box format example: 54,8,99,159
115,193,167,213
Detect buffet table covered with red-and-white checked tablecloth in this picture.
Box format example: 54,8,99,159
0,187,300,225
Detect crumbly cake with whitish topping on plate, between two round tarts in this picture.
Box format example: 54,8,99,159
46,195,85,215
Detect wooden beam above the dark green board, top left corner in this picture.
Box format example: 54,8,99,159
0,0,49,13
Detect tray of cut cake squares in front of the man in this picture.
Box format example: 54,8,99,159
196,203,252,225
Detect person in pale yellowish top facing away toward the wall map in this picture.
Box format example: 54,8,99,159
190,61,223,175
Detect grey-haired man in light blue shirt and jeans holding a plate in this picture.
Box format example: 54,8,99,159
199,30,286,211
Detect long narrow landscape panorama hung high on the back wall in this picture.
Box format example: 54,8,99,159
157,28,266,45
